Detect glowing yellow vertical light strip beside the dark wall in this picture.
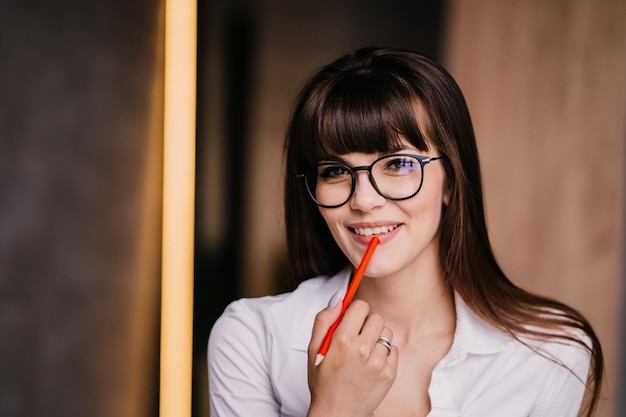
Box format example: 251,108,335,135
159,0,197,417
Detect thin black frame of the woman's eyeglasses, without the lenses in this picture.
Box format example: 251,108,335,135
296,153,444,208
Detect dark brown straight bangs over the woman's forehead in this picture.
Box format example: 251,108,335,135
298,70,428,164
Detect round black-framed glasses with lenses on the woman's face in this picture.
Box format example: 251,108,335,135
297,153,443,208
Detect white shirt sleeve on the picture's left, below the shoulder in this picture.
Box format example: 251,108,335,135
207,300,280,417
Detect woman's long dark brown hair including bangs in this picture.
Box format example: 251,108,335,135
285,47,603,417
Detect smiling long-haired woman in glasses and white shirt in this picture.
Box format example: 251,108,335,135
208,48,603,417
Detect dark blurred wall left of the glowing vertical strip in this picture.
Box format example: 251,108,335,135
0,0,163,417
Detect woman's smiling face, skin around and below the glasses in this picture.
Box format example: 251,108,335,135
320,143,448,277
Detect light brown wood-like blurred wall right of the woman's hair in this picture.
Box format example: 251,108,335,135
445,0,626,417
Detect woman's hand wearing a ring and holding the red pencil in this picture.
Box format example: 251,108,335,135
308,300,398,417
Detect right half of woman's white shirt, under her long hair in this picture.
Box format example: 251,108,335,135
444,294,590,416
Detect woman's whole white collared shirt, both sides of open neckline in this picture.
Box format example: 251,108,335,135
208,269,590,417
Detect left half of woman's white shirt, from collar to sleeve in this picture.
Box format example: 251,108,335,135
207,271,349,416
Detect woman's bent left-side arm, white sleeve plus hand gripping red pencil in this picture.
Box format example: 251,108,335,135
208,292,398,417
